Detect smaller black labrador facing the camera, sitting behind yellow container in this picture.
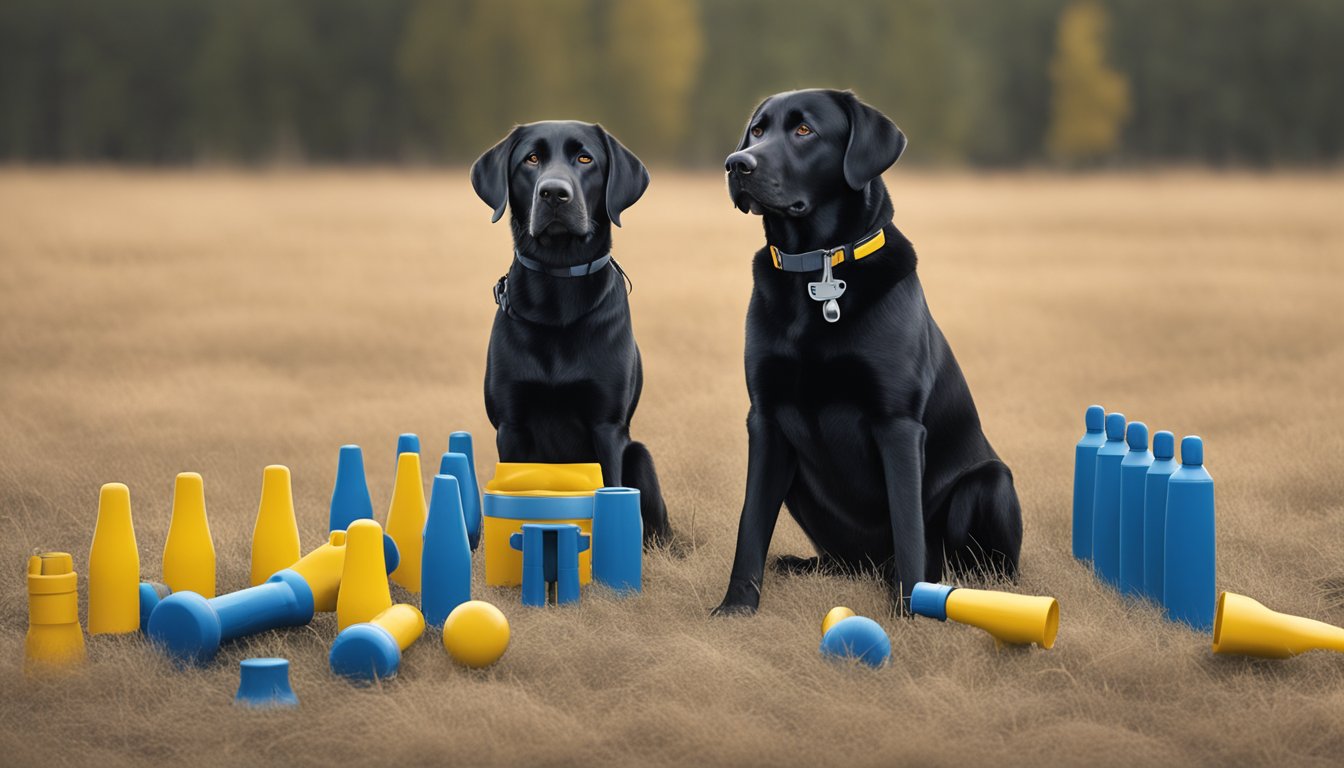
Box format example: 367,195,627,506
472,121,671,543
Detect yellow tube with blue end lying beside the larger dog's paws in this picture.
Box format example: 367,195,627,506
910,581,1059,648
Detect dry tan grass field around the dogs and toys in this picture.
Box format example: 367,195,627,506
0,168,1344,767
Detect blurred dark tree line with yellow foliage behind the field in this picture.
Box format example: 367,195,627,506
0,0,1344,165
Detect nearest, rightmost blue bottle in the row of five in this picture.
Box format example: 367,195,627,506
1163,436,1218,632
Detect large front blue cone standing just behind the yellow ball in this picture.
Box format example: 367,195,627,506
421,475,472,627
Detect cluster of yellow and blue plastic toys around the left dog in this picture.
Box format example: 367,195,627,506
26,432,642,706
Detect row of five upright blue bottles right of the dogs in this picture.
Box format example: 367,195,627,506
1074,405,1218,631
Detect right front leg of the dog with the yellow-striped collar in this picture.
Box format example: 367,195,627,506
875,417,929,612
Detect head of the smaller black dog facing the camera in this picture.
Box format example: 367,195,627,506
472,120,649,239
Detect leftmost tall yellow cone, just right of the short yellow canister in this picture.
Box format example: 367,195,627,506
89,483,140,635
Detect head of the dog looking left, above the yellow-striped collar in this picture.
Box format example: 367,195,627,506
724,89,906,218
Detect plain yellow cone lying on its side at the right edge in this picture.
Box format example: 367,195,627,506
1214,592,1344,659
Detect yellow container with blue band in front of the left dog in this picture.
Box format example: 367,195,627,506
481,461,602,586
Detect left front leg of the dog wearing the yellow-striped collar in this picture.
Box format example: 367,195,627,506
714,410,797,616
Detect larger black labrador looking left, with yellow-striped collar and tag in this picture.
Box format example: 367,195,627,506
715,90,1021,613
